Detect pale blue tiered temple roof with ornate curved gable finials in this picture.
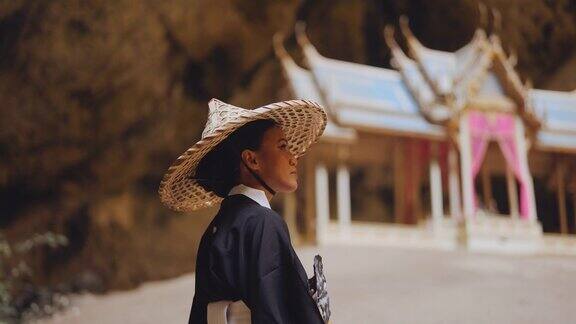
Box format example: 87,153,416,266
275,18,576,152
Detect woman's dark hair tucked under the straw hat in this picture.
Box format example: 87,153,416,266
195,119,277,198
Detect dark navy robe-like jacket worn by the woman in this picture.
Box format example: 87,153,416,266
189,195,322,324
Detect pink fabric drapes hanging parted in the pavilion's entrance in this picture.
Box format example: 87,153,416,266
469,112,530,219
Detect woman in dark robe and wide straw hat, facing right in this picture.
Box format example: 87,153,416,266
159,99,326,323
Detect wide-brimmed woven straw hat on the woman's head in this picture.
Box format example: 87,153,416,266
158,99,326,211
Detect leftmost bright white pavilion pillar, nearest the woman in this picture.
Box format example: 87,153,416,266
315,163,330,243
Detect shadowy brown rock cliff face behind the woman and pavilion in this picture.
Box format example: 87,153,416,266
0,0,576,289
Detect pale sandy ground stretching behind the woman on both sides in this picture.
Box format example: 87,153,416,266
42,246,576,324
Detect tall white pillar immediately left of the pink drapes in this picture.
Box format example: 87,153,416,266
458,113,474,219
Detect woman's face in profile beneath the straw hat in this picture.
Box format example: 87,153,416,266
256,126,298,192
